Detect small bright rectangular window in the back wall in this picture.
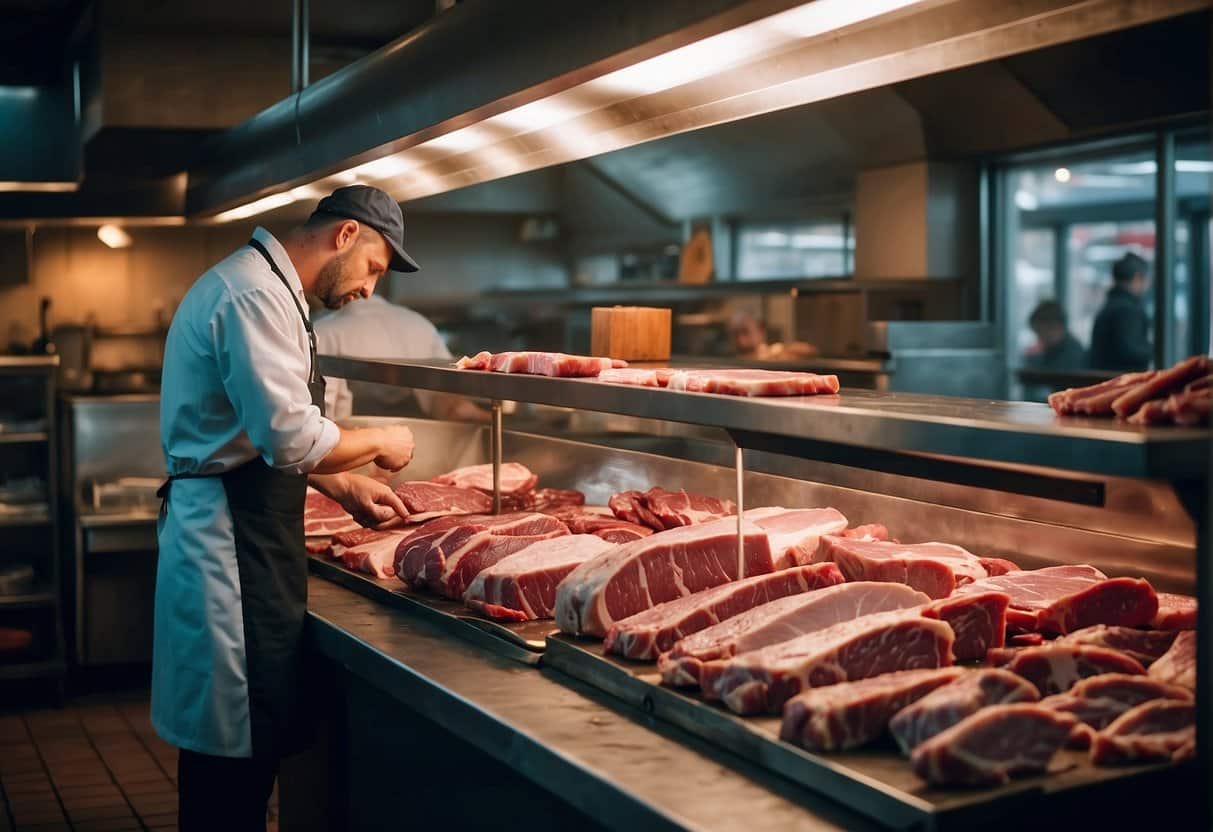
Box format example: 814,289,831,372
736,220,855,280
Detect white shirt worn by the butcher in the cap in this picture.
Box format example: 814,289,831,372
160,228,341,474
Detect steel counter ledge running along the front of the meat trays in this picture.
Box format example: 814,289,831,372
308,577,876,832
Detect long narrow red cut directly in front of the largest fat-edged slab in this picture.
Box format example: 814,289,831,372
604,563,842,659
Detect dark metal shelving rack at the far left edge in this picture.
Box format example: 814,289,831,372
0,355,67,701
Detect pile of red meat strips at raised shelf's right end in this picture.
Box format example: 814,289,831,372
1049,355,1213,424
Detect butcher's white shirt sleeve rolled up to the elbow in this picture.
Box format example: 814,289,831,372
211,289,341,474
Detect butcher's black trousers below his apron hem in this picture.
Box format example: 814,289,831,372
177,748,278,832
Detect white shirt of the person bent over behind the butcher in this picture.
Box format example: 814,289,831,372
315,295,451,418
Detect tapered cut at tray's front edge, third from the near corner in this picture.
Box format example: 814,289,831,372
779,667,964,751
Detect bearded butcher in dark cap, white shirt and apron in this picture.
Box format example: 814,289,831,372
152,186,417,832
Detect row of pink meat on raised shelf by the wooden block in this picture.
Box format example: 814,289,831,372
455,352,838,397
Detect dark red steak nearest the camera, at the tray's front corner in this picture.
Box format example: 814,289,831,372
910,702,1075,786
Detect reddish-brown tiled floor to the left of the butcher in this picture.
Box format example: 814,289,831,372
0,694,274,832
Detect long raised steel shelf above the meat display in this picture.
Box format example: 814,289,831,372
320,355,1209,480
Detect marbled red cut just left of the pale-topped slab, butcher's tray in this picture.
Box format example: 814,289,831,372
395,512,569,598
